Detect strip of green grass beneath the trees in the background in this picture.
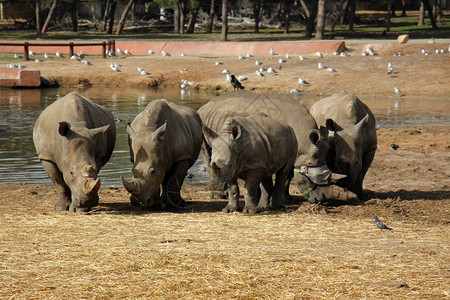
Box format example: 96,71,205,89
0,12,450,41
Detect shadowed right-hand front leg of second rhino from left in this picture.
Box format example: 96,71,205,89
161,160,192,209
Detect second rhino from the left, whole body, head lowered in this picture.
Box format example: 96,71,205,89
121,99,203,209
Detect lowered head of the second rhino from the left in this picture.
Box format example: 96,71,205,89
120,121,168,207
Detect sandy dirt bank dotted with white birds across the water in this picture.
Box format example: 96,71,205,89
0,41,450,98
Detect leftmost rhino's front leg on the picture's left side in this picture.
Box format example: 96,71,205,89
41,160,72,210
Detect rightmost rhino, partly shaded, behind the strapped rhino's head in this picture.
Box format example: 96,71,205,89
311,92,377,199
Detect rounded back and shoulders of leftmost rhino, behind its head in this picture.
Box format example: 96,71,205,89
33,92,116,165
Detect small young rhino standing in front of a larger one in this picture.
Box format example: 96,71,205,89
203,115,297,214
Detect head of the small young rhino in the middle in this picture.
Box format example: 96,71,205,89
203,119,242,183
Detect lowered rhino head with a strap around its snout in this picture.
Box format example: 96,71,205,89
294,126,345,203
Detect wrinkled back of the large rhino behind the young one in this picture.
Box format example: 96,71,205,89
198,90,317,150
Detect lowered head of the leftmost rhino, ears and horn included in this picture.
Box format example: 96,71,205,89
58,122,110,211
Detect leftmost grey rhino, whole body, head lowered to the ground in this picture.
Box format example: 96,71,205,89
33,92,116,211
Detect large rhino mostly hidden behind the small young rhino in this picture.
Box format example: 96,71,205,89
198,90,331,203
